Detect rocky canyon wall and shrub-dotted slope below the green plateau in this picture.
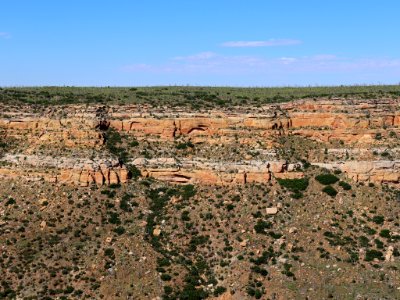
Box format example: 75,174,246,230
0,98,400,299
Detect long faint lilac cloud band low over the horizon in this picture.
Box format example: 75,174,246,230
121,52,400,78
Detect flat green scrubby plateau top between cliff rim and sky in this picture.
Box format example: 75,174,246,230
0,85,400,108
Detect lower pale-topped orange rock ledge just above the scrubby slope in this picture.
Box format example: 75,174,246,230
0,154,400,186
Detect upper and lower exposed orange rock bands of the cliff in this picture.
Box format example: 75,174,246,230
0,99,400,186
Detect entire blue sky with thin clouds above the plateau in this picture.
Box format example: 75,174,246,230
0,0,400,86
